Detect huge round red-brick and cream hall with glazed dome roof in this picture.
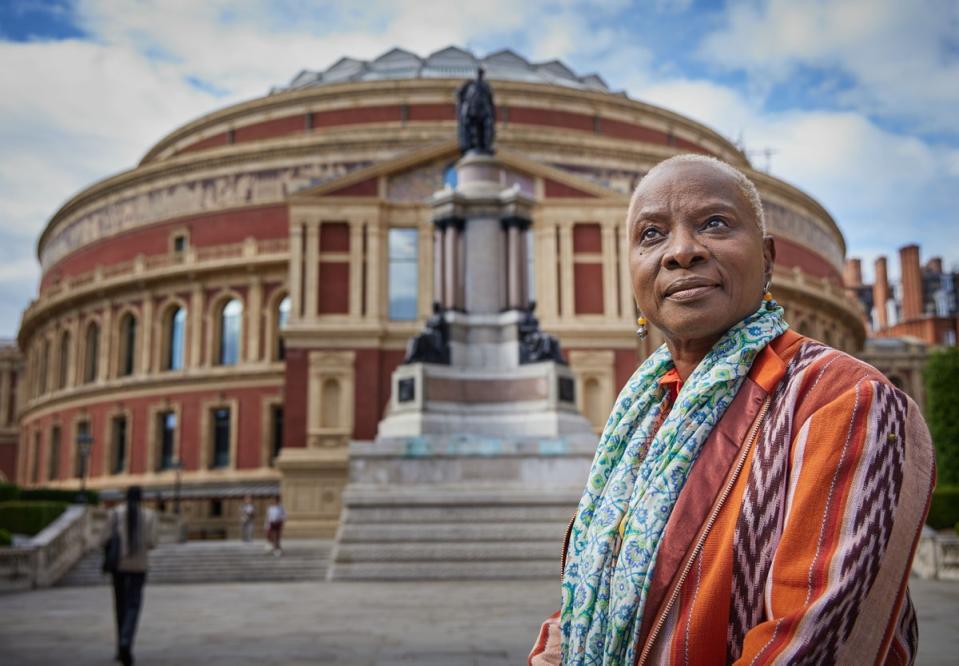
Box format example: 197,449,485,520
17,47,865,536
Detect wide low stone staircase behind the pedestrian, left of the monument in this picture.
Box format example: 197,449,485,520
57,539,332,586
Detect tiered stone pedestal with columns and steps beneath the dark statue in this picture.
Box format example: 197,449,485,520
328,155,596,580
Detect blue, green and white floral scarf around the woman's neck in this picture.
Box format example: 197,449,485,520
560,305,789,665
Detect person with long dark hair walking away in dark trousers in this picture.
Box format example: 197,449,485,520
104,486,156,666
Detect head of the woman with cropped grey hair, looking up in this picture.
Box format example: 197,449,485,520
629,162,775,346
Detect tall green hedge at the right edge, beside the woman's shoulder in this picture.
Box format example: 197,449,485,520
923,347,959,482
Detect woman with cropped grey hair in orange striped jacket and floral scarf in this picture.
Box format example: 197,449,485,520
530,155,934,664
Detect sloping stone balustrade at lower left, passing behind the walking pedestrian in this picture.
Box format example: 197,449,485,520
0,504,183,592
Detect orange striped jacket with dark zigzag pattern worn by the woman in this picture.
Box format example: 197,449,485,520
530,331,935,665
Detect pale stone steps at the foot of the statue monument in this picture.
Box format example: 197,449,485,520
328,484,579,580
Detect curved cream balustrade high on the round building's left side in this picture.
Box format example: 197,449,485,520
23,238,289,322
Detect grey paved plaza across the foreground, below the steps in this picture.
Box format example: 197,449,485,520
0,580,959,666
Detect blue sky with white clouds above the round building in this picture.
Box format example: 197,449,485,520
0,0,959,337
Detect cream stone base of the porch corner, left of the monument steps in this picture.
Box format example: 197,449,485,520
276,447,347,539
